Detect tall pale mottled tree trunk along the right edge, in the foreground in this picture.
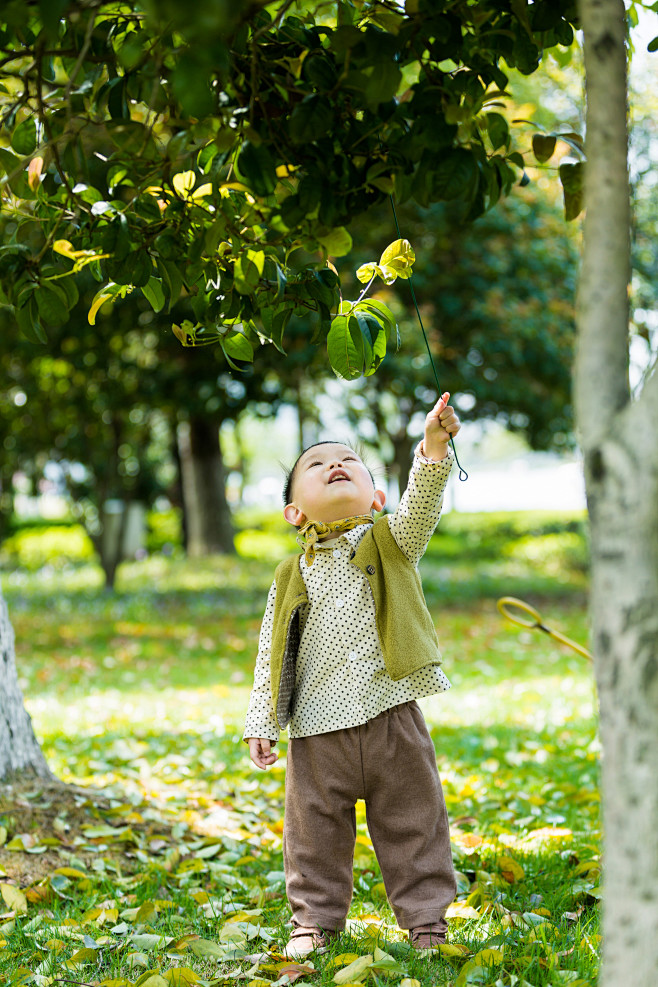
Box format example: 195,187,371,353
575,0,658,987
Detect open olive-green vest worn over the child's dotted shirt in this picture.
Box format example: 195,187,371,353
271,517,441,729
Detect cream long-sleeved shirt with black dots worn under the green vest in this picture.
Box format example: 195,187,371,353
244,446,454,740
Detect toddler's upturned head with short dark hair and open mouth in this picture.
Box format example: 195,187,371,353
283,442,386,527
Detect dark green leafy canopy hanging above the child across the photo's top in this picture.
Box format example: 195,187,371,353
0,0,578,367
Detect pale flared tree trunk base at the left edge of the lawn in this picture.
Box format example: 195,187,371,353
0,594,54,782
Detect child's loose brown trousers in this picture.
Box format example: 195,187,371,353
283,702,456,930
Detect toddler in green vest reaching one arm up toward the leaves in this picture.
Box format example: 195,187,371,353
244,393,460,958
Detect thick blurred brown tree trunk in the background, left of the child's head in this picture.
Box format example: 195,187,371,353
178,416,235,558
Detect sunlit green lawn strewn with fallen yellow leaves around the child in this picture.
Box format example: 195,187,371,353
0,515,599,987
